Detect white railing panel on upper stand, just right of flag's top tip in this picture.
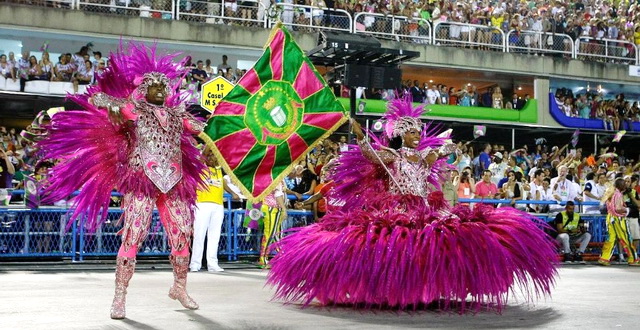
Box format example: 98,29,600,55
268,3,353,32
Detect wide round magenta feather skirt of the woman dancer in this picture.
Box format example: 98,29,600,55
268,193,557,312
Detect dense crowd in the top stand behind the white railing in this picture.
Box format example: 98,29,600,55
9,0,640,49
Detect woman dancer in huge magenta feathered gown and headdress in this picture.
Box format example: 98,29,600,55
268,98,556,311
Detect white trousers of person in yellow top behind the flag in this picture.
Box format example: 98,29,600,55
189,203,224,270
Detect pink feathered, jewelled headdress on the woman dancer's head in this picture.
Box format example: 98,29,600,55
383,95,424,139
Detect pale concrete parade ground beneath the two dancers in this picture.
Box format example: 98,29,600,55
0,263,640,330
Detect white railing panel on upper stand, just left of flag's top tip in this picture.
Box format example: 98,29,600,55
176,0,267,28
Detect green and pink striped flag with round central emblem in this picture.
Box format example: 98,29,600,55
200,24,348,199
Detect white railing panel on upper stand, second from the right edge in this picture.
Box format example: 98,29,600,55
506,30,575,58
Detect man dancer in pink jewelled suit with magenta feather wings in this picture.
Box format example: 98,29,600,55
41,43,204,319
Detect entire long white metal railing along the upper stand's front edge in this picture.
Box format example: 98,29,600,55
5,0,640,65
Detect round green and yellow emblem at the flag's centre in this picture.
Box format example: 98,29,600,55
244,80,304,145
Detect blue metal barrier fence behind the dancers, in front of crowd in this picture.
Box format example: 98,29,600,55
0,196,607,261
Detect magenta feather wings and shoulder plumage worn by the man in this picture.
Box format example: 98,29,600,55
38,43,204,231
